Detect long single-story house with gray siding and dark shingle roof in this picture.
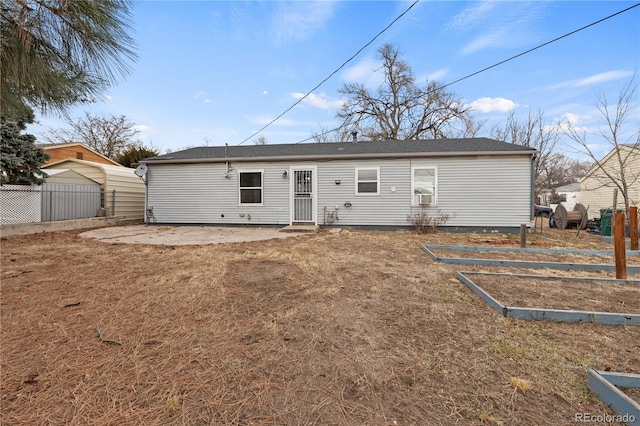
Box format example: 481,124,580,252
140,138,537,230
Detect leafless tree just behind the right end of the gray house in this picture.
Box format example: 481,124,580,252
491,110,561,198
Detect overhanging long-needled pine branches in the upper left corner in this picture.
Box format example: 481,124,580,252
0,0,136,114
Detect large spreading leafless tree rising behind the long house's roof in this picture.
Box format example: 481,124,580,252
336,44,474,140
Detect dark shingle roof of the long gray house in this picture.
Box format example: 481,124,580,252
141,138,536,164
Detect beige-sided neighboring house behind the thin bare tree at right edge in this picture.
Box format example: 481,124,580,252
580,145,640,219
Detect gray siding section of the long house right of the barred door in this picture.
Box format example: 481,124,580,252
318,156,531,228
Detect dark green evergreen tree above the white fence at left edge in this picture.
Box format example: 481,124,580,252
0,106,49,185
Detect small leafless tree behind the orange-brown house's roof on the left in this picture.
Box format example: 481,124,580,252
44,113,141,161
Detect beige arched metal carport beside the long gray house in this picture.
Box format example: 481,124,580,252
42,159,145,220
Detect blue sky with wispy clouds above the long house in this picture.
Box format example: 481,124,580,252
29,0,640,160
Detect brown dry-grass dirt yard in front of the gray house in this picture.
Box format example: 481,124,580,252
0,225,640,425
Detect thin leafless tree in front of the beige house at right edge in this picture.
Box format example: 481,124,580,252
568,76,640,221
